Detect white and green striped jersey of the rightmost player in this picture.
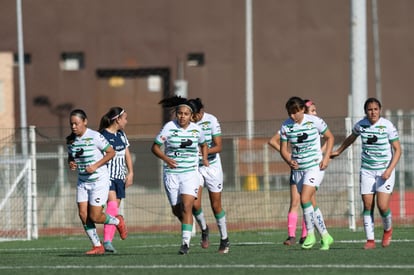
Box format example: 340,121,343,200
352,117,399,170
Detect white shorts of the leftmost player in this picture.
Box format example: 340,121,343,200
76,178,111,206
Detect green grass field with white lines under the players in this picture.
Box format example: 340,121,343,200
0,227,414,275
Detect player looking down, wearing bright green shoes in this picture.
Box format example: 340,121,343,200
280,97,334,250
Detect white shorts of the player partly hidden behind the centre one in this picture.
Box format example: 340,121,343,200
198,160,223,193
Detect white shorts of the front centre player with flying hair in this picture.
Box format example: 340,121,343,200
164,170,200,206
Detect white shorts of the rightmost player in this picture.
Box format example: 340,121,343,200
359,169,395,195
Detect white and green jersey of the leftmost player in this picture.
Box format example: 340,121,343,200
68,128,111,182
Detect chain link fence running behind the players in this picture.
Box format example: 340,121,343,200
0,113,414,238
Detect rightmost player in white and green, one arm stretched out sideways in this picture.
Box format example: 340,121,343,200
331,98,401,249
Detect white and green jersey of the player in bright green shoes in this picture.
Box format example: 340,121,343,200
280,114,328,170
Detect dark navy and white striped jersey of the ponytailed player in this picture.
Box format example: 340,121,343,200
101,129,129,180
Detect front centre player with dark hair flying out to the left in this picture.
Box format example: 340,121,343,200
151,98,209,255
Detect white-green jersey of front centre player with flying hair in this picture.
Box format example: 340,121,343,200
154,120,205,174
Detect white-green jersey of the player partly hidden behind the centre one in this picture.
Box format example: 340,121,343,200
197,113,221,166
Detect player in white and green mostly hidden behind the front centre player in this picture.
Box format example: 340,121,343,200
189,98,230,253
